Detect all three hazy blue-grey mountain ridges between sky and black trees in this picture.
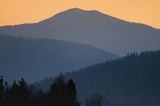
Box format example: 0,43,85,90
0,8,160,106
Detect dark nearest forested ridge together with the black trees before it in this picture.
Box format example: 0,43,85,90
0,50,160,106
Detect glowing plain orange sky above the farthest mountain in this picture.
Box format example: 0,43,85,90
0,0,160,28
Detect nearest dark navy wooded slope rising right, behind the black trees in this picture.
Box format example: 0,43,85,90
37,51,160,106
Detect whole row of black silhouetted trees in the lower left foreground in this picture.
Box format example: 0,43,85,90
0,76,80,106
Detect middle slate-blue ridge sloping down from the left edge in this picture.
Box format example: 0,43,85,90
0,34,118,82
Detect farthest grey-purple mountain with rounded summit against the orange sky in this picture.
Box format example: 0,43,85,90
0,8,160,55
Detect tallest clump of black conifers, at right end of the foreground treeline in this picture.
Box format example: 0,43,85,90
47,75,79,106
